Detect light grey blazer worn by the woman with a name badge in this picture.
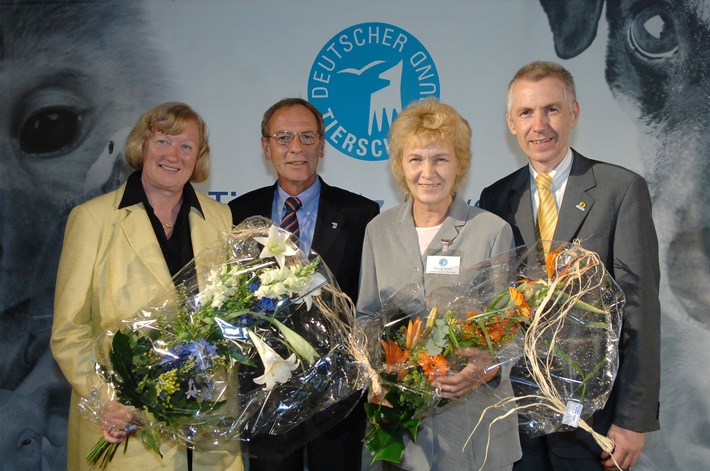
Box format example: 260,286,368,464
357,197,521,471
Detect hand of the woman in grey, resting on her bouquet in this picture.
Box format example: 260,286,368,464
433,348,499,398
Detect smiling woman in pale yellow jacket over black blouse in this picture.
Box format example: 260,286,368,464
51,103,243,471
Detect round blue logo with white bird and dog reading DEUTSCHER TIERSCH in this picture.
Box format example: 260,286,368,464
308,23,439,160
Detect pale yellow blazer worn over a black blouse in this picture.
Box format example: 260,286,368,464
50,184,243,471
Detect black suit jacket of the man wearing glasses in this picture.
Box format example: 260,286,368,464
229,177,380,471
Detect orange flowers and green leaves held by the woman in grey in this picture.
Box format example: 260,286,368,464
364,276,529,462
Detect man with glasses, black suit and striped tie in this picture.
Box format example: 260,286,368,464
229,98,380,471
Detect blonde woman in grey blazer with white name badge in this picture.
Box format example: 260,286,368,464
357,99,520,471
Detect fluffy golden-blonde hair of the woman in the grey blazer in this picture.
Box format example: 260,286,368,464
388,98,471,195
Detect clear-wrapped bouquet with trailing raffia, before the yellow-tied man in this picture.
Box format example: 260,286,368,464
511,243,625,436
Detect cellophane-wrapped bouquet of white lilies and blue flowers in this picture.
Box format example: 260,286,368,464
80,217,367,464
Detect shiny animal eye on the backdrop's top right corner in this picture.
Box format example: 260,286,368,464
627,5,678,59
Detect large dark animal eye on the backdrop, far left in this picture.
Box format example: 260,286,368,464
15,89,86,159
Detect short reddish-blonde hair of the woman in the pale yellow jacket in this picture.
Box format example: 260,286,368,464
125,102,210,183
